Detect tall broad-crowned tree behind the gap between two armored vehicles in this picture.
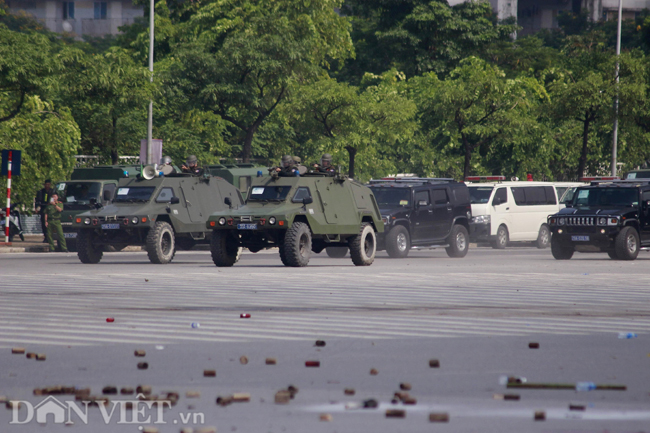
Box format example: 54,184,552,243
165,0,352,161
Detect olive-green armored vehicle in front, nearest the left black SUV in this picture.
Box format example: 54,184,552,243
206,173,384,267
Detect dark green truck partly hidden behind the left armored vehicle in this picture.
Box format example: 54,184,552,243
55,165,140,252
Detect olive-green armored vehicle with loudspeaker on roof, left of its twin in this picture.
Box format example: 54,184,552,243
73,172,243,264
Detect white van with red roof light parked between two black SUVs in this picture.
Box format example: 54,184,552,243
467,178,560,249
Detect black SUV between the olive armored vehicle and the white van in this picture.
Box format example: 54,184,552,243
369,178,472,258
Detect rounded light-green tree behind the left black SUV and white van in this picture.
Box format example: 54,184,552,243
411,57,545,179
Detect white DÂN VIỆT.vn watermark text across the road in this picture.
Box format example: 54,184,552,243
9,394,205,425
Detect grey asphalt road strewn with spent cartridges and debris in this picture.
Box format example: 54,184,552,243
0,248,650,433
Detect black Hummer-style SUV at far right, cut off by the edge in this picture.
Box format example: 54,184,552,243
548,180,650,260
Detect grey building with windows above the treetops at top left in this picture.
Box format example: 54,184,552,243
5,0,144,37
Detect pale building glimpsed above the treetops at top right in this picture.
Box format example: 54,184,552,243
449,0,650,36
